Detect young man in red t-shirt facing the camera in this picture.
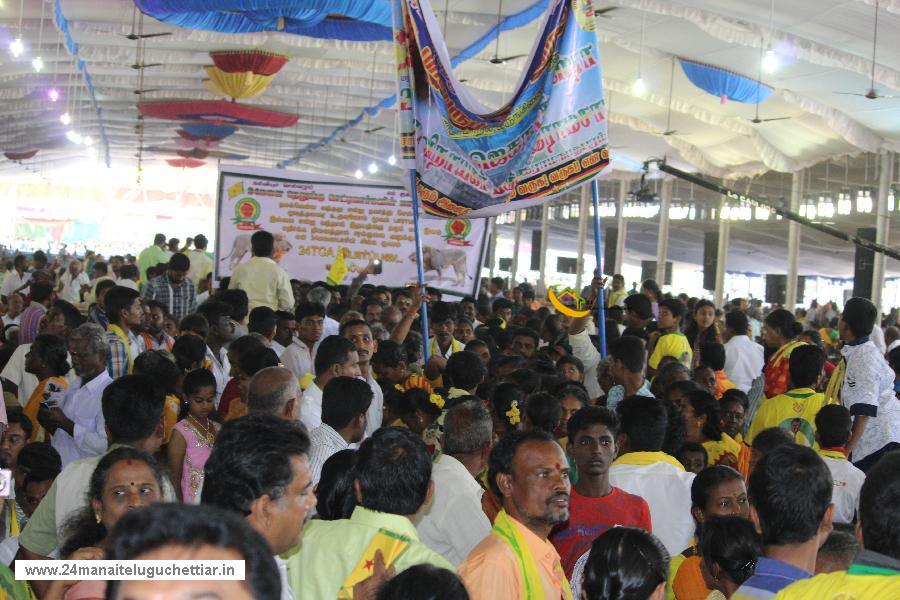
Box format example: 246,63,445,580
550,406,651,577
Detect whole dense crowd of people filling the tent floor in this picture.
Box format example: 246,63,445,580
0,231,900,600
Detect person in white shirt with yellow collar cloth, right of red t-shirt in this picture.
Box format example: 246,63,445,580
609,396,694,556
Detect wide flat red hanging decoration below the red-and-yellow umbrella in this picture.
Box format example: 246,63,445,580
138,100,298,128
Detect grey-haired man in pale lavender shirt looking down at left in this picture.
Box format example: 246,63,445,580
38,323,112,468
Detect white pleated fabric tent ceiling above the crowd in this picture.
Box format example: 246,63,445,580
0,0,900,178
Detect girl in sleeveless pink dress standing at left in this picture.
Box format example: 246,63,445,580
166,369,219,504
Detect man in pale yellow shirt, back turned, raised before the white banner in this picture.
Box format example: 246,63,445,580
228,231,294,310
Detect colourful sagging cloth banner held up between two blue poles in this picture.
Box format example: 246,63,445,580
394,0,609,218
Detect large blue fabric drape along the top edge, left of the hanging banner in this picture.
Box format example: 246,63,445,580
135,0,392,42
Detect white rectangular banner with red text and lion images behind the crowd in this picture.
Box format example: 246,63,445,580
215,165,487,296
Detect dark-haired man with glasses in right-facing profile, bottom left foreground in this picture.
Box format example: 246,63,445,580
201,414,316,600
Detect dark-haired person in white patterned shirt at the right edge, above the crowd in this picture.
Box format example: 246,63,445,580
838,298,900,471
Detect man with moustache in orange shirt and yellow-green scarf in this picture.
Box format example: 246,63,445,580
459,430,572,600
